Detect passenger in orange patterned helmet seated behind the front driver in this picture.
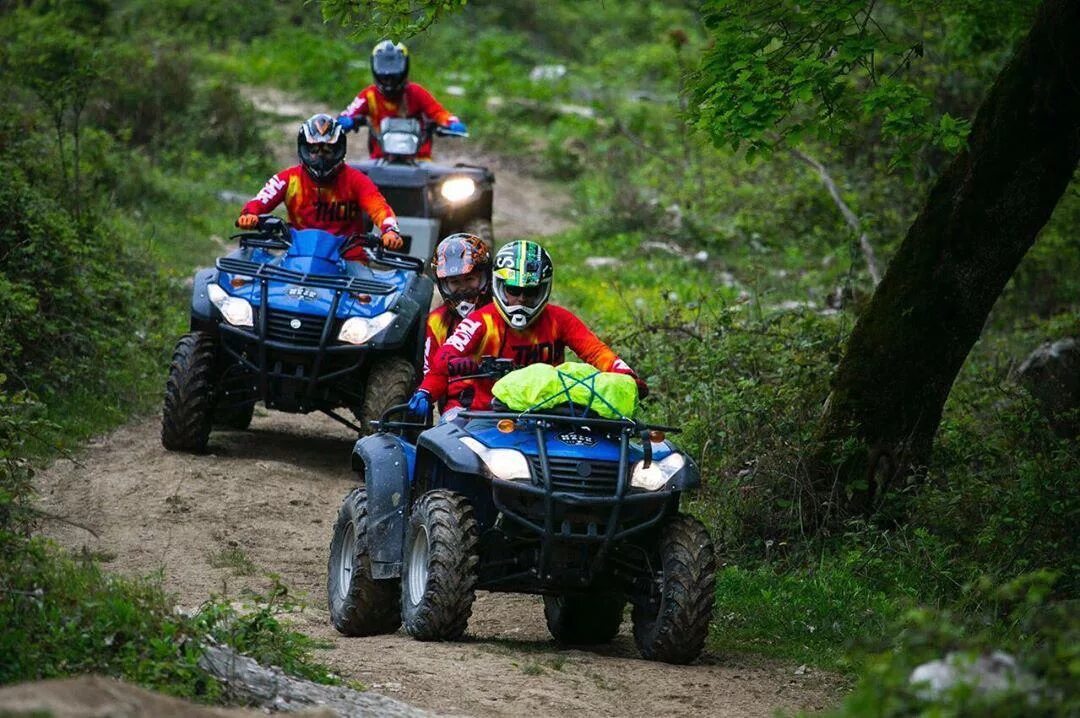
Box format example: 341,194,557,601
423,233,491,374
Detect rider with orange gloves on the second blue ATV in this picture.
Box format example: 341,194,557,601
237,114,404,262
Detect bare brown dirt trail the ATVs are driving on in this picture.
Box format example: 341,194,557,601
31,86,839,716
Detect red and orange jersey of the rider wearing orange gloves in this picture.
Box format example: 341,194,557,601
242,165,397,260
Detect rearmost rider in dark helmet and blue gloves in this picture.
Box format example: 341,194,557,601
338,40,467,160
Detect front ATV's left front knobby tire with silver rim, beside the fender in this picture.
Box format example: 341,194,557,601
402,489,480,640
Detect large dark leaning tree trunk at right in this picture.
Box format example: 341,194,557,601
811,0,1080,519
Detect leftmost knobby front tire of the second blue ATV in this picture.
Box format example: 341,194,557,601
161,331,216,453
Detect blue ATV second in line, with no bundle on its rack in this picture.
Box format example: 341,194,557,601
161,215,433,453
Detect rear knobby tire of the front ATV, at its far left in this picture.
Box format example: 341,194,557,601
326,489,402,636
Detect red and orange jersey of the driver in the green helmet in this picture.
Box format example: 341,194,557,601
420,303,636,410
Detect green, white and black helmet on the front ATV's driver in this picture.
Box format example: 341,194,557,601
491,240,554,329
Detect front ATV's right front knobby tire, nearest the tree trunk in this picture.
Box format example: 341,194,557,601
632,514,716,663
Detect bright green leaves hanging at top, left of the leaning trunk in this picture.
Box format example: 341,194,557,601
692,0,1035,166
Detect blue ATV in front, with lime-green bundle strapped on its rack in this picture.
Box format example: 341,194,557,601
327,357,716,663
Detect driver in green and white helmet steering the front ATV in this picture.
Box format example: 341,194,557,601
409,241,648,418
